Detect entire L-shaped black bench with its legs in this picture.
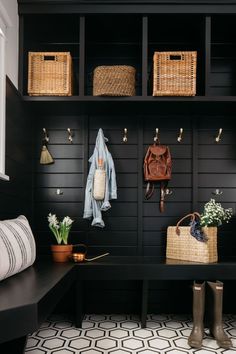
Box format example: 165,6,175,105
0,256,236,354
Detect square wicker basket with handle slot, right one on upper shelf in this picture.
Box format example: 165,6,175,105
153,52,197,96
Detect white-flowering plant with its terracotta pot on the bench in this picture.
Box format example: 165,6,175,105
48,213,74,262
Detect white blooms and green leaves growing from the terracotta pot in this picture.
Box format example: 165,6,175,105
48,213,74,245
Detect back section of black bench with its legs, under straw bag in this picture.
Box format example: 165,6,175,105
75,256,236,327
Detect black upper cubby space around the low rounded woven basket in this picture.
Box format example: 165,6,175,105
85,15,142,96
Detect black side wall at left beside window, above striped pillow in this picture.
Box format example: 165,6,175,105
0,78,33,220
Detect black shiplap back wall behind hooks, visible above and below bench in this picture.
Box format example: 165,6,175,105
34,108,236,312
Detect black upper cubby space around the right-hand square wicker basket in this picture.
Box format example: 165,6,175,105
148,15,205,96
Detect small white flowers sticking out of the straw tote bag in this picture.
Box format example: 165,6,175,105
200,199,233,226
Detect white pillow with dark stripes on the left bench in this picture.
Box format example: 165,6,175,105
0,215,36,280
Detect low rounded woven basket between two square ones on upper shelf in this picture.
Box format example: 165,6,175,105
93,65,135,96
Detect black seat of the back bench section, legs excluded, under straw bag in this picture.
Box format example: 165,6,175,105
76,256,236,280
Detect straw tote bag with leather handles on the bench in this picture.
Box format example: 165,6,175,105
166,214,218,263
